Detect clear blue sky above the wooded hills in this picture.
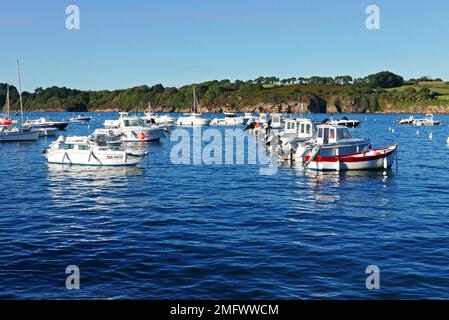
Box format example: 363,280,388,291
0,0,449,90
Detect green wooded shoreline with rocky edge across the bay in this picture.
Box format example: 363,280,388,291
0,71,444,112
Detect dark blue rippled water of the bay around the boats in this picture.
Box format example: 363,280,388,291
0,114,449,299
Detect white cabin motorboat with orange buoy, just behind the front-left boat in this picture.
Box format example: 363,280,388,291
105,113,164,142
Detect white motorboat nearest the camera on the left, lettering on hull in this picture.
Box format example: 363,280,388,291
44,136,147,166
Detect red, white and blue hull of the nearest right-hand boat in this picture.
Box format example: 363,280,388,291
304,145,398,171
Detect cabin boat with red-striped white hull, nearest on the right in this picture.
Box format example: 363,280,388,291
295,124,398,171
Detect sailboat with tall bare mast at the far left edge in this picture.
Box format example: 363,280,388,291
0,60,39,142
